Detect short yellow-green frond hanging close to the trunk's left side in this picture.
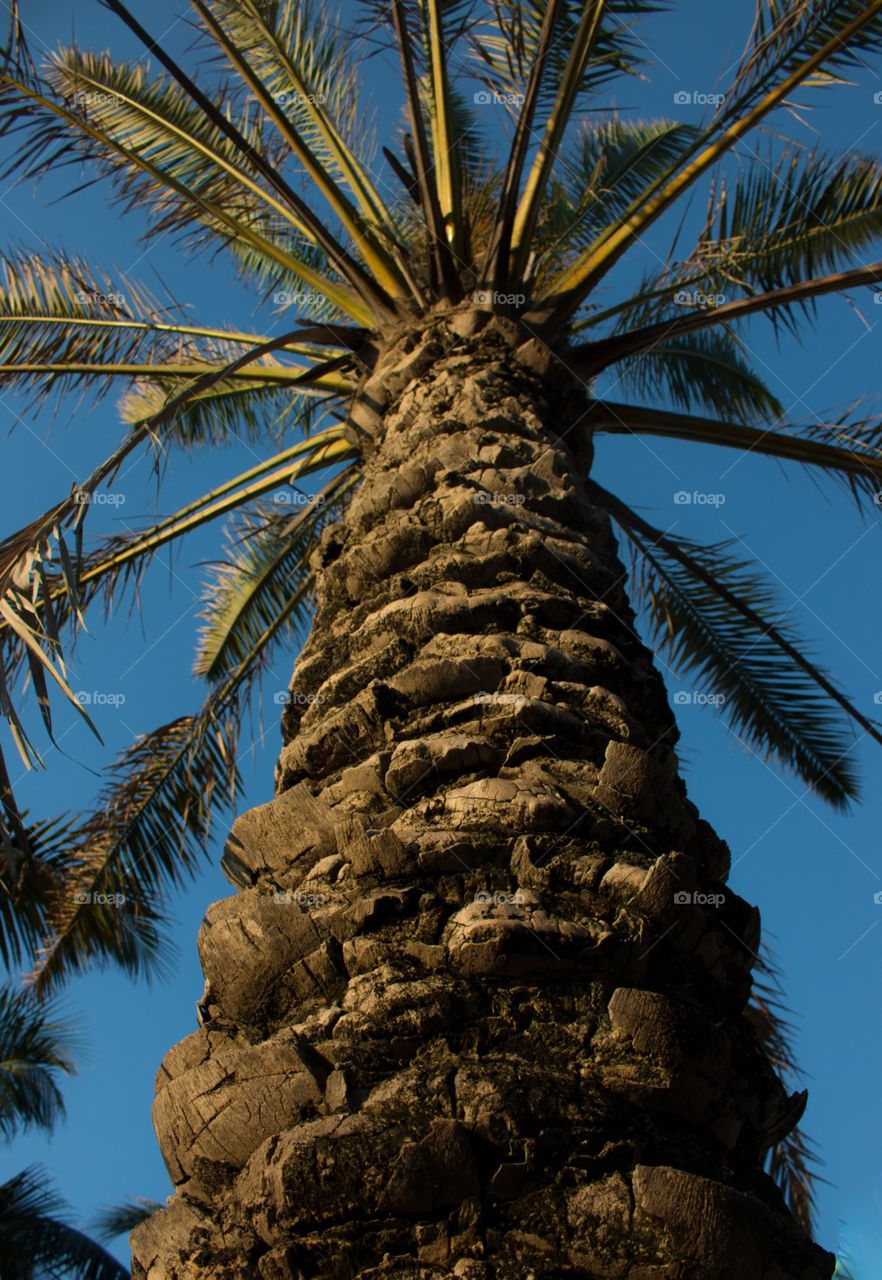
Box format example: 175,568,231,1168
193,467,357,681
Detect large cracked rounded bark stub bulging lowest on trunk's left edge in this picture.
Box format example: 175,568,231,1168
154,1029,326,1183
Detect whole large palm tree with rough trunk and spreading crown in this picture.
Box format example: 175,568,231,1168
0,0,882,1280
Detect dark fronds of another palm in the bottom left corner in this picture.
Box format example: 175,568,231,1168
0,983,128,1280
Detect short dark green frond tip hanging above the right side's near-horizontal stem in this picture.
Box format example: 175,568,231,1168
599,329,783,422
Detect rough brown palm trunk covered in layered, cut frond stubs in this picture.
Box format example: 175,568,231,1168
133,316,833,1280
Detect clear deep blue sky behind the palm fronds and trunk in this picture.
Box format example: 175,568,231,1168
0,0,882,1280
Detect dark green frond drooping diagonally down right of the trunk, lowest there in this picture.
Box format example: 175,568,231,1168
589,481,865,808
